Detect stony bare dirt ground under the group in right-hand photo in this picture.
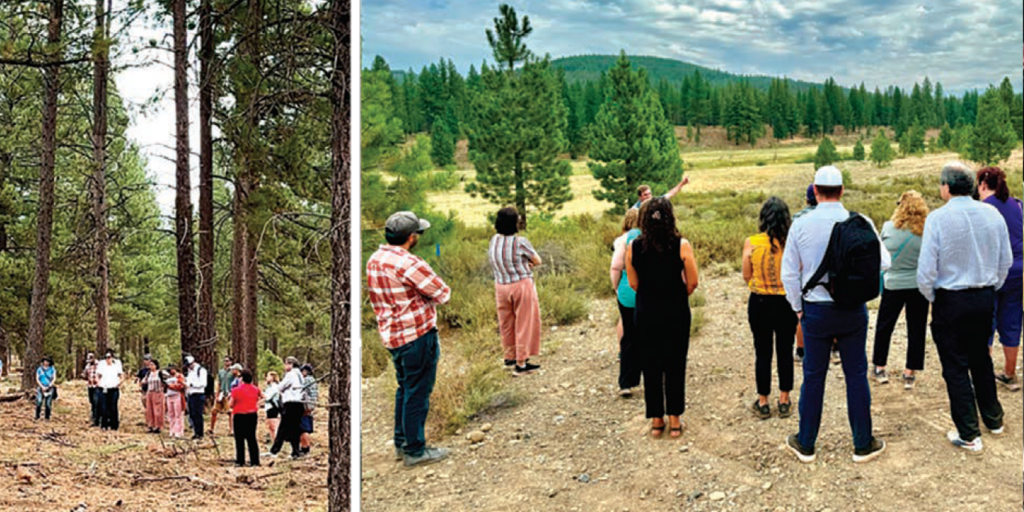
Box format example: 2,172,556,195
362,274,1024,512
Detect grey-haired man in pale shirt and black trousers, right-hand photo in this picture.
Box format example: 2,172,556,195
918,162,1014,452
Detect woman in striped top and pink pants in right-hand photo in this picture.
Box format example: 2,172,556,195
487,208,541,377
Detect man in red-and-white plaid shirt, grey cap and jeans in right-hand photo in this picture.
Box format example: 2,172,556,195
367,212,452,467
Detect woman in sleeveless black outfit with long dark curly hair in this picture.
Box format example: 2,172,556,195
626,198,697,438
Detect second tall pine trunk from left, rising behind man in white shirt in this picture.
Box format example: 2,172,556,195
92,0,111,352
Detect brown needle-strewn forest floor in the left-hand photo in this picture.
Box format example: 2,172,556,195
0,376,328,512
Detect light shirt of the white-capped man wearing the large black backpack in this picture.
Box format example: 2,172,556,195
782,202,892,312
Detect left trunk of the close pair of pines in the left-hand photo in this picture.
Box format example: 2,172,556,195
172,0,197,360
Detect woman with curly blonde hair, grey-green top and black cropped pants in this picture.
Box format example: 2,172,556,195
871,190,929,390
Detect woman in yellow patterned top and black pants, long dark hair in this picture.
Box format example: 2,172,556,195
743,198,797,420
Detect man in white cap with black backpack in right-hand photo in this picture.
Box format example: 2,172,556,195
782,166,891,463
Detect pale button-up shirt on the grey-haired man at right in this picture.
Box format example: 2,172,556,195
918,197,1014,302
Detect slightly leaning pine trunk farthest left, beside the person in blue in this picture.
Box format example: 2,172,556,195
22,0,63,391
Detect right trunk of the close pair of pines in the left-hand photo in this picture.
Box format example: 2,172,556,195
193,0,217,368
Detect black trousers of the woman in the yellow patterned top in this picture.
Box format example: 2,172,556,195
746,294,797,396
